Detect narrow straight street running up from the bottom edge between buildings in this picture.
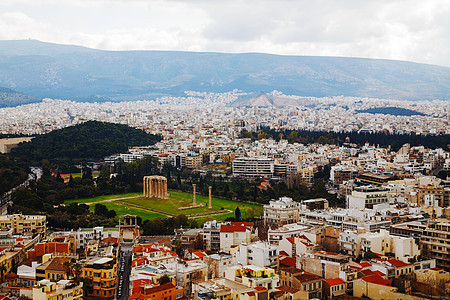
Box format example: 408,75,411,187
116,243,133,300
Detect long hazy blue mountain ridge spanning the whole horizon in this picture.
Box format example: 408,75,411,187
0,40,450,101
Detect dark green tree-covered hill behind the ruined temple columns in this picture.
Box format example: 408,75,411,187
11,121,161,163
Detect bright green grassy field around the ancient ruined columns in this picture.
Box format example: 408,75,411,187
64,190,263,223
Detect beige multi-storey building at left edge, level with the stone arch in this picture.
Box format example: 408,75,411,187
0,214,47,235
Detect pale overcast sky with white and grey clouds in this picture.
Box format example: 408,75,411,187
0,0,450,66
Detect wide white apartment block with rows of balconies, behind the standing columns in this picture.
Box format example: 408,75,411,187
233,156,274,178
